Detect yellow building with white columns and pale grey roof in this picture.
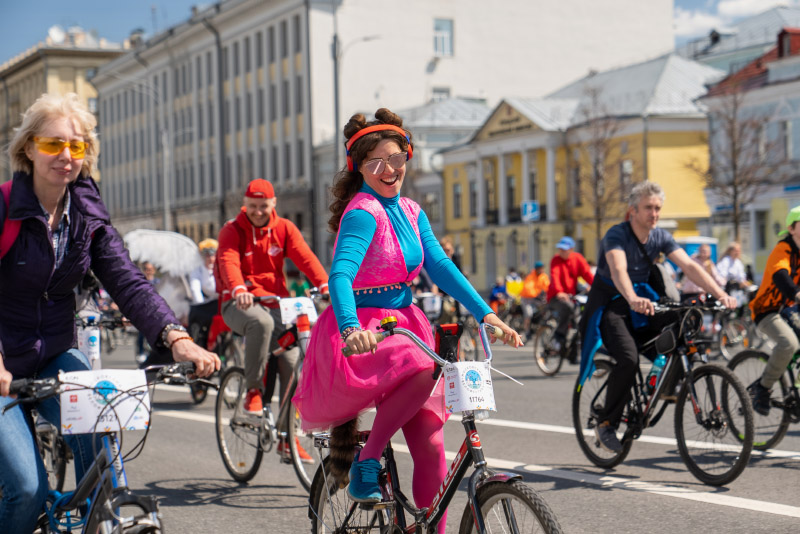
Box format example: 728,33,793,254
443,55,721,290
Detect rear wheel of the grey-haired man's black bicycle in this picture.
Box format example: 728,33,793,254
572,360,633,469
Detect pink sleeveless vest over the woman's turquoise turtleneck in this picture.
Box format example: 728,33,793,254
333,192,425,290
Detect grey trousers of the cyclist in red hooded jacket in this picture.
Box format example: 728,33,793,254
222,299,300,401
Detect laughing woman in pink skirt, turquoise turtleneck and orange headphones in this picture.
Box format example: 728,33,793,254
293,108,522,531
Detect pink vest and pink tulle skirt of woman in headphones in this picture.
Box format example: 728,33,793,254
292,193,446,430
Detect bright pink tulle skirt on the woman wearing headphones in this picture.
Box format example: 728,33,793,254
292,305,446,430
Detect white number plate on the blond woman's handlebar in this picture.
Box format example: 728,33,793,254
58,369,150,434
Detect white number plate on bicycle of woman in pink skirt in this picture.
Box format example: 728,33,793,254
444,362,497,413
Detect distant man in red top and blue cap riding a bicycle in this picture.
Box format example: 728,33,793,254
547,236,594,363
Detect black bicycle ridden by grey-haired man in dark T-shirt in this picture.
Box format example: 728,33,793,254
572,304,753,486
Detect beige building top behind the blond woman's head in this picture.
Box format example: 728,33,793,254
0,26,123,181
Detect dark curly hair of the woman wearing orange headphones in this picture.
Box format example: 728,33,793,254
328,108,413,233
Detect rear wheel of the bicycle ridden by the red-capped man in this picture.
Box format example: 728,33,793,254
214,367,264,483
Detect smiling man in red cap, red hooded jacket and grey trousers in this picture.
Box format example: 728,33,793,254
217,178,328,428
